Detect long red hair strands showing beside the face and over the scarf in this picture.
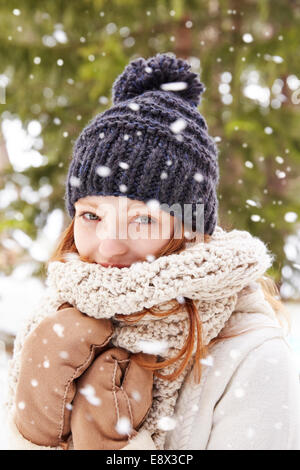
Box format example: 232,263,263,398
46,218,290,383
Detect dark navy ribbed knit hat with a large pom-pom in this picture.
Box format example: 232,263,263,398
65,53,219,235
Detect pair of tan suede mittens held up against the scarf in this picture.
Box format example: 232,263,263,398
14,303,155,450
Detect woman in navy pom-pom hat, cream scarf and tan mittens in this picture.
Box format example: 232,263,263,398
4,54,300,450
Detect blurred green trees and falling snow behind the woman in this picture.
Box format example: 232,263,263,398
0,0,300,446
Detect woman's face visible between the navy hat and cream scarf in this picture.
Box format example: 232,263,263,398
74,196,174,267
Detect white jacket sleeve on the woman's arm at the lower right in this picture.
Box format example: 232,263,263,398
206,338,300,450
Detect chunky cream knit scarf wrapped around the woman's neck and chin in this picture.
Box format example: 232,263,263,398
10,226,274,449
